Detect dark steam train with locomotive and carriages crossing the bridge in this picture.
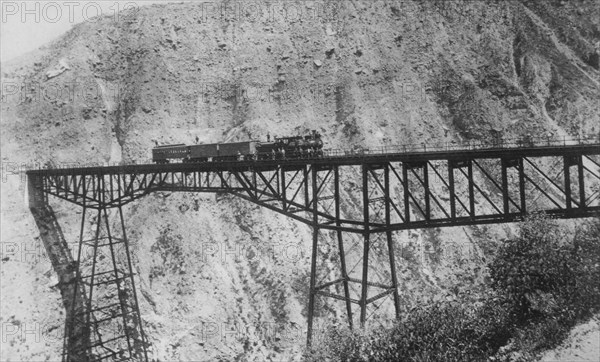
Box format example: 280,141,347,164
152,130,323,164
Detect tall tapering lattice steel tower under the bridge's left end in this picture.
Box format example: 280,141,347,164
63,206,148,362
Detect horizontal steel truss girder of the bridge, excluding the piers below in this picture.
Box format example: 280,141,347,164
29,154,600,228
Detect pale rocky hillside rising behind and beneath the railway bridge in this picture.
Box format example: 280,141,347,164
1,0,600,361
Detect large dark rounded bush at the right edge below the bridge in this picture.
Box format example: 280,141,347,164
489,215,600,324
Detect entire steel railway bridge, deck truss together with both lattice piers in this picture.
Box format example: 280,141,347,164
27,139,600,361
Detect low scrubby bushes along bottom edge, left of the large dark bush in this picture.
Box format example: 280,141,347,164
307,294,512,362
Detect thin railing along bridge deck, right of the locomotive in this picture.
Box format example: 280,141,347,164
323,135,600,157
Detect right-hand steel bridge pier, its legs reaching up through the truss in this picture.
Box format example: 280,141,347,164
307,163,400,346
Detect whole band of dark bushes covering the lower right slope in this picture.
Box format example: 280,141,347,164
307,215,600,361
